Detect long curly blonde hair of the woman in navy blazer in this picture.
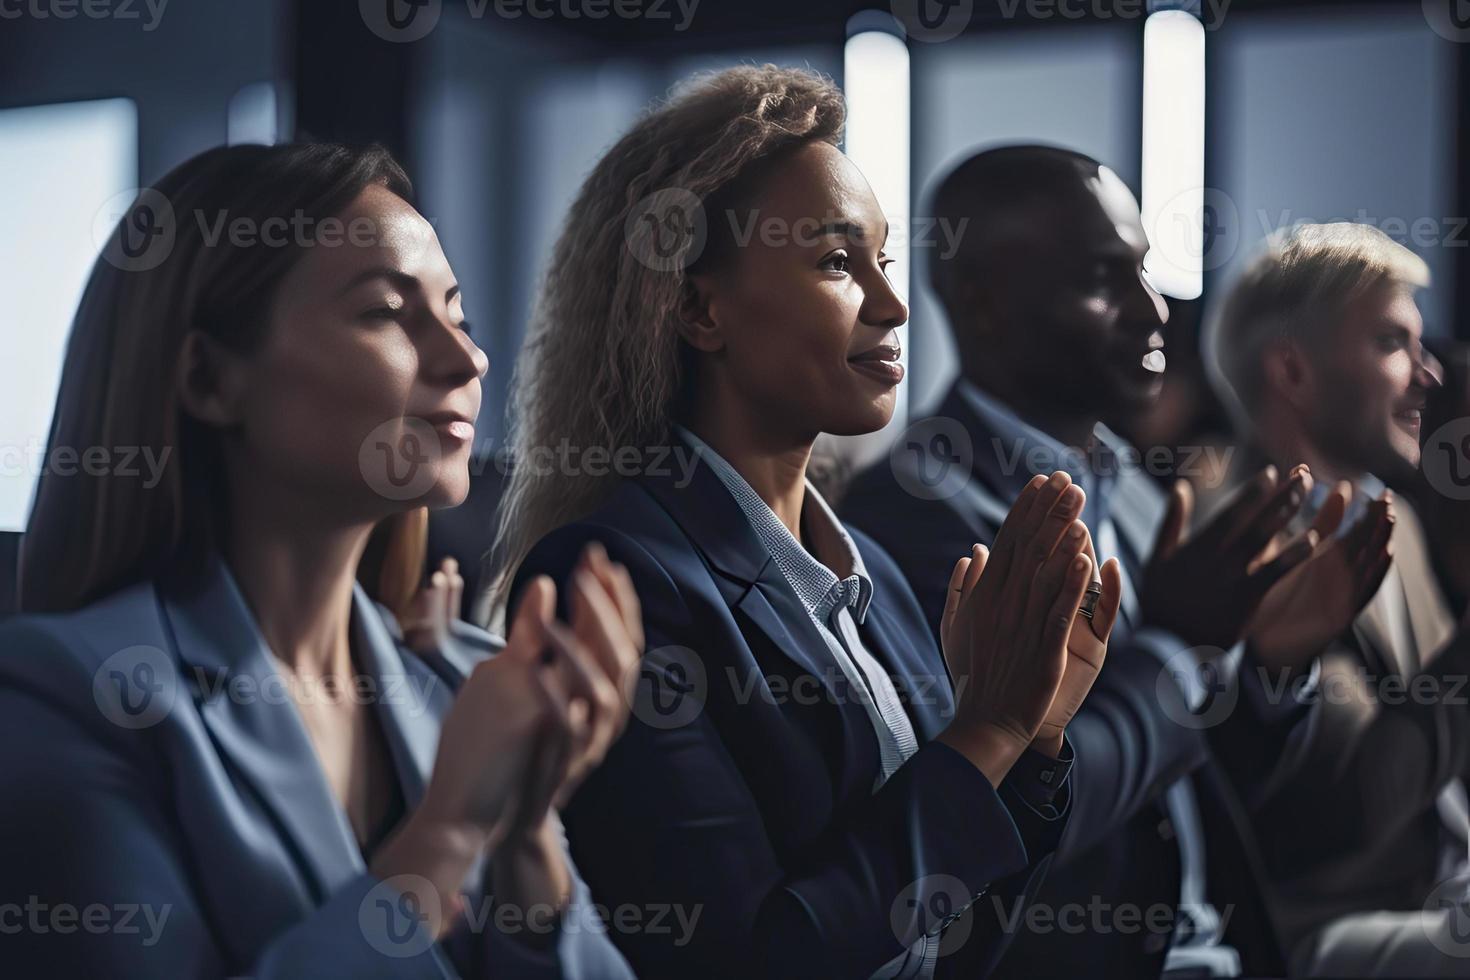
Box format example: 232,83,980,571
491,65,845,605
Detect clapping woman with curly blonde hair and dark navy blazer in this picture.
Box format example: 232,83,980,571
498,66,1117,977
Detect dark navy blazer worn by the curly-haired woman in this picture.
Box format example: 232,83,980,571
512,447,1066,980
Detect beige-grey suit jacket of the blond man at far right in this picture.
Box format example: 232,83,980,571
1254,497,1470,942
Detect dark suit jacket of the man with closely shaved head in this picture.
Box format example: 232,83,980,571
841,389,1283,980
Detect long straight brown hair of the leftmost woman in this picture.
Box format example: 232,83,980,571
21,144,412,611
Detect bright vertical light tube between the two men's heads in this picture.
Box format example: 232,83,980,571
1144,10,1205,300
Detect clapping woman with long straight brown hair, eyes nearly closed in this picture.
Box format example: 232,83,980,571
0,144,642,977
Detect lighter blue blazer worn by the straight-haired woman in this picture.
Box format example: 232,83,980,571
0,561,632,980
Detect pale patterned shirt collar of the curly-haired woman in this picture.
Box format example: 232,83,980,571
673,425,873,623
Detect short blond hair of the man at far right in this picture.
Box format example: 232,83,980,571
1204,222,1429,430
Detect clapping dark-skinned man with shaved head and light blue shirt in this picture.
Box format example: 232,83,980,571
844,147,1381,980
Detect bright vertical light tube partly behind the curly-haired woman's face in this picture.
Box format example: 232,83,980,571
842,31,911,452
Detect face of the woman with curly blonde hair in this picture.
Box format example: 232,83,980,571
684,143,908,438
